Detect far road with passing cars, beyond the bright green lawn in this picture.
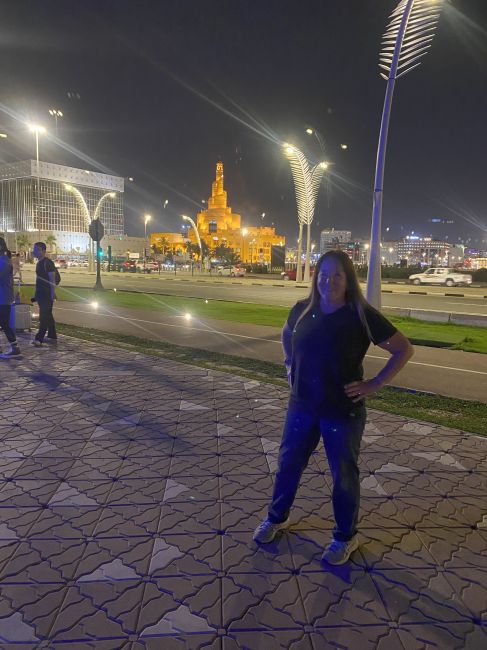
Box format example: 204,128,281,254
23,269,487,316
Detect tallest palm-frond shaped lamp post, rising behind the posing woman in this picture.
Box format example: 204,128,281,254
367,0,444,309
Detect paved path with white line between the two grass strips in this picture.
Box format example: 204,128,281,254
55,302,487,403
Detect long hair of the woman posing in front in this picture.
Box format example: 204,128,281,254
296,249,372,341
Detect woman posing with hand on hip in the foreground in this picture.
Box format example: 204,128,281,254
254,250,413,565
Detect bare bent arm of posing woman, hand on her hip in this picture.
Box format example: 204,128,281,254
345,332,414,402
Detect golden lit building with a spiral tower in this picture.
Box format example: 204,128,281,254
188,161,286,264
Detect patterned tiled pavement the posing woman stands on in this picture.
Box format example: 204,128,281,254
0,338,487,650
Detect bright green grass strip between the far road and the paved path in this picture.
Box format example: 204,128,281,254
22,286,487,354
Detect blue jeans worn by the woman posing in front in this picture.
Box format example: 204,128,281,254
269,406,366,541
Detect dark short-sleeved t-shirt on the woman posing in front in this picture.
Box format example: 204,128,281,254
287,301,397,416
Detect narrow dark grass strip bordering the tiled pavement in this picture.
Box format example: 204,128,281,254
58,324,487,436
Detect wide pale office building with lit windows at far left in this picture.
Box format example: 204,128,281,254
0,160,124,254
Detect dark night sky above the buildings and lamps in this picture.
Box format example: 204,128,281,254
0,0,487,248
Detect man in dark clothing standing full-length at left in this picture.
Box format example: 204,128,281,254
32,242,57,347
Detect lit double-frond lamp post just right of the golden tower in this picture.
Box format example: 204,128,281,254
284,144,328,282
